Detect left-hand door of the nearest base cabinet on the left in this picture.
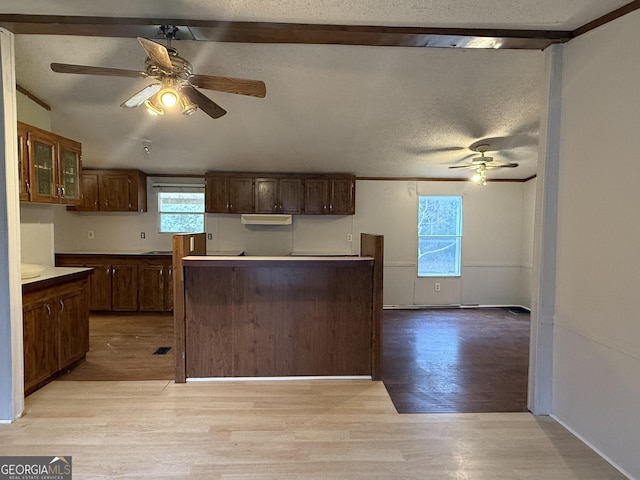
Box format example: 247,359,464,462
22,298,58,391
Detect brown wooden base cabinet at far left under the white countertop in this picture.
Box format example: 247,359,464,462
22,272,89,395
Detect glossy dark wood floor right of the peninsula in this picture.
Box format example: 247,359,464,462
382,308,529,413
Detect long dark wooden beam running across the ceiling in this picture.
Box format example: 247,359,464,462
0,14,572,50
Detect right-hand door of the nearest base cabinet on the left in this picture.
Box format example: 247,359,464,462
54,281,89,369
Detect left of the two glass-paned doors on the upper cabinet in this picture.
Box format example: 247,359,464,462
27,131,58,203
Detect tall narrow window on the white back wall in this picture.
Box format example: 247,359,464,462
418,196,462,277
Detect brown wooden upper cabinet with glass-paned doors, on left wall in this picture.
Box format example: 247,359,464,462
18,123,81,204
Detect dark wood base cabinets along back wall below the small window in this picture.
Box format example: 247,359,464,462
56,254,173,312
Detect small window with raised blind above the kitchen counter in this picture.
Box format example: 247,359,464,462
156,185,204,233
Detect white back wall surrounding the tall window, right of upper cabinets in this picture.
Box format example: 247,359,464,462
354,181,532,306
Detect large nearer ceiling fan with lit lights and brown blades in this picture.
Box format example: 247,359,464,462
51,25,267,118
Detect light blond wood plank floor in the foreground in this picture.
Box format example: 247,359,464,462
0,380,624,480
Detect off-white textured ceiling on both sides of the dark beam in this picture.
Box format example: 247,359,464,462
0,0,629,179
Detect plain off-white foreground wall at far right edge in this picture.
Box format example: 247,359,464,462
553,10,640,478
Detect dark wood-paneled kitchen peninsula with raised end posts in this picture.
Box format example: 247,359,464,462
173,234,383,382
